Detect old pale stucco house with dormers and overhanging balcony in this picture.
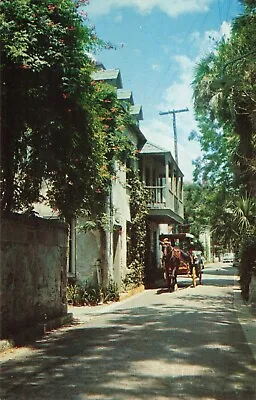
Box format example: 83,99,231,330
35,64,183,290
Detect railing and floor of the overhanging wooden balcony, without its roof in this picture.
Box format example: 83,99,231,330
146,185,184,223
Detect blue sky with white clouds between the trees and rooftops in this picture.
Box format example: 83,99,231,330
85,0,242,181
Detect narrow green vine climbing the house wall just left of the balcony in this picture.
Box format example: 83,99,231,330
123,169,148,287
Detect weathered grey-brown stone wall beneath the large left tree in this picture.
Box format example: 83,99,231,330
0,214,68,338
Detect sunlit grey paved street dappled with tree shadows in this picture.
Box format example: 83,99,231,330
1,265,256,400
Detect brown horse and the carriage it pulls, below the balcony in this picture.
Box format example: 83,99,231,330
159,233,202,291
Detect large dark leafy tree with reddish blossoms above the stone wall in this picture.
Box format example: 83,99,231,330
0,0,105,217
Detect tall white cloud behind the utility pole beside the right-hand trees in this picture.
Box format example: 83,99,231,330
146,18,230,181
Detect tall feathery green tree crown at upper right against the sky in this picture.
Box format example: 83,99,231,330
193,2,256,194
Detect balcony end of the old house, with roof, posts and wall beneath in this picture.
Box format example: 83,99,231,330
140,142,184,282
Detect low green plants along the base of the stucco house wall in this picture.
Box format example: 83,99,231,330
67,280,119,306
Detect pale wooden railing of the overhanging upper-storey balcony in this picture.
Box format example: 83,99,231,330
146,185,183,217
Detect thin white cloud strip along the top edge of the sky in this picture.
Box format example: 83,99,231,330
87,0,214,17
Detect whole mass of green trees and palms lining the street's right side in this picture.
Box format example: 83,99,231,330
191,0,256,298
